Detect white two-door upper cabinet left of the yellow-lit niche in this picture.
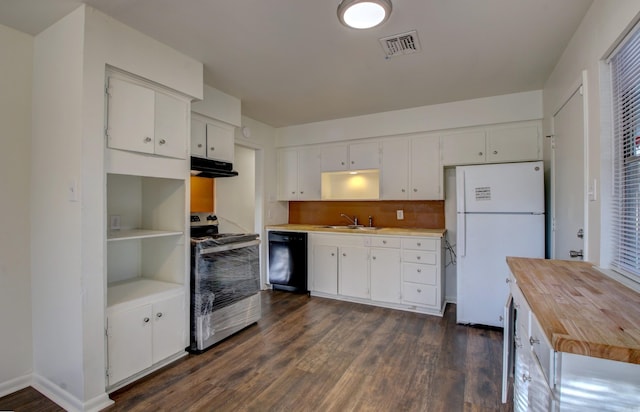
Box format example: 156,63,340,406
278,147,321,200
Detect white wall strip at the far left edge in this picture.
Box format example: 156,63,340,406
0,25,33,396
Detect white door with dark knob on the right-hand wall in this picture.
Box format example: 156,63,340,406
551,85,586,260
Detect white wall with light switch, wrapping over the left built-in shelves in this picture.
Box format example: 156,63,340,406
31,5,203,410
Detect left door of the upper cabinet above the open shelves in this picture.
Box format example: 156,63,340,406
107,78,155,153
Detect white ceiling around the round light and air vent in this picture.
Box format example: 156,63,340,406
0,0,592,127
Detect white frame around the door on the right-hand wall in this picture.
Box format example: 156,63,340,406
548,70,596,261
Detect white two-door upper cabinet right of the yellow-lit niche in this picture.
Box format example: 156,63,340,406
380,135,444,200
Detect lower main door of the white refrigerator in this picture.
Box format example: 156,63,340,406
457,214,544,327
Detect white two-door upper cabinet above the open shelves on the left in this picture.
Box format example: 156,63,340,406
106,77,189,159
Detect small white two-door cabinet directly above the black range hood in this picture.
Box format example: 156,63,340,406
191,113,235,163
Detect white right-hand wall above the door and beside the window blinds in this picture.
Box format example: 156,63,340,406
544,0,640,267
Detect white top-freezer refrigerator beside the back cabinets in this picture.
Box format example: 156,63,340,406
456,162,545,327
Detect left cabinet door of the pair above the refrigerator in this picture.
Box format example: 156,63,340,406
440,131,485,166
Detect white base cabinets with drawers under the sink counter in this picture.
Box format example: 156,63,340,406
309,232,444,315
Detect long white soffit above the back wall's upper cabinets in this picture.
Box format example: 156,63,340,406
276,90,542,147
